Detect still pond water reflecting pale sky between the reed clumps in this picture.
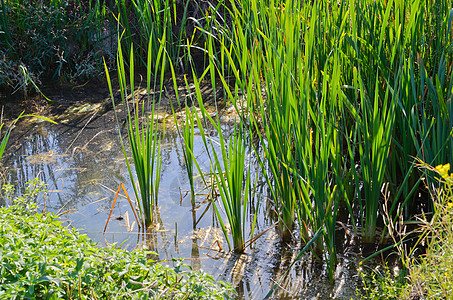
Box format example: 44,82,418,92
3,97,360,299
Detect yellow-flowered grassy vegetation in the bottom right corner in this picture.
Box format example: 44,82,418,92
359,163,453,299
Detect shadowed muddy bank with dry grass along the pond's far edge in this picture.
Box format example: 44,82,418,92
0,73,225,122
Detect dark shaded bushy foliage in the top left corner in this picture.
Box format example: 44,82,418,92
0,0,109,90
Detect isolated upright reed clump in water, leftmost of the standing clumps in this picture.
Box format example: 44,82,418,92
105,36,166,227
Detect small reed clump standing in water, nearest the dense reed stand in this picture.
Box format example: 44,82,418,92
188,68,258,253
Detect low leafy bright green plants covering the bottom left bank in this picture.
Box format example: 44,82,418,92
0,182,232,299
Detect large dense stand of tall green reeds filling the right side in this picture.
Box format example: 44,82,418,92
186,0,452,269
